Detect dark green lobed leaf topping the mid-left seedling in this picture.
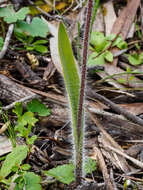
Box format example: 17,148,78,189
27,99,50,116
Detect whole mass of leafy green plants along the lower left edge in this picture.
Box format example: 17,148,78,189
0,99,50,190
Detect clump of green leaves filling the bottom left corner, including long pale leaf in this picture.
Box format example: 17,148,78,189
0,145,42,190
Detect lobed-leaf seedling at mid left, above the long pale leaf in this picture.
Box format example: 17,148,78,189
13,99,50,145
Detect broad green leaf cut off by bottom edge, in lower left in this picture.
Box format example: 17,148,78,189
24,172,42,190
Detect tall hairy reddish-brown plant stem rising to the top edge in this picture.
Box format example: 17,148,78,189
75,0,93,184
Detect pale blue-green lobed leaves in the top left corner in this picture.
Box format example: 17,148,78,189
0,5,49,38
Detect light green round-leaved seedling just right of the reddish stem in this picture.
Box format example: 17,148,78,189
88,31,128,66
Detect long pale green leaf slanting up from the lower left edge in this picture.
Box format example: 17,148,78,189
0,145,28,178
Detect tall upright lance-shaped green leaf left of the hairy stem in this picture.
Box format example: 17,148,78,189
58,22,80,145
